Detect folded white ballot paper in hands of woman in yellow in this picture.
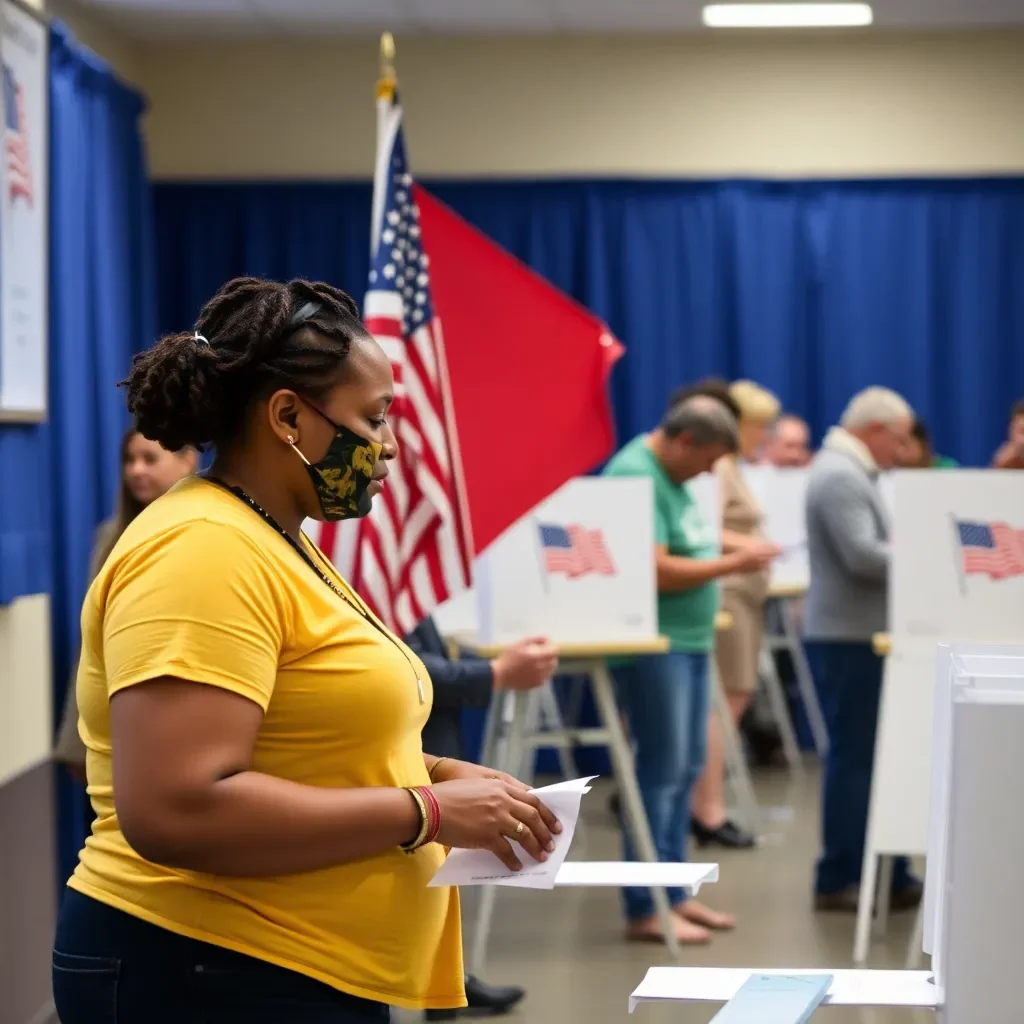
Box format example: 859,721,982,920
430,775,597,889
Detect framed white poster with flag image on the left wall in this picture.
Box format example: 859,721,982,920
0,0,49,423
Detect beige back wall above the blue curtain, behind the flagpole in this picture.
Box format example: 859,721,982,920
140,33,1024,177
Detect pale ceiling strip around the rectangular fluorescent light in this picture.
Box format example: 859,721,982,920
79,0,1024,38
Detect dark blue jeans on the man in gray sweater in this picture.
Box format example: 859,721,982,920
807,642,914,893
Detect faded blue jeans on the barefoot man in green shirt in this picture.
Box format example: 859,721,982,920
614,651,709,921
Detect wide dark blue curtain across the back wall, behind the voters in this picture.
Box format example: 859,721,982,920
156,178,1024,465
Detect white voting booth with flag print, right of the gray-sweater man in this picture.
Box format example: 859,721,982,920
854,470,1024,963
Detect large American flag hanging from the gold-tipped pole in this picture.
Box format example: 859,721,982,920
351,87,473,634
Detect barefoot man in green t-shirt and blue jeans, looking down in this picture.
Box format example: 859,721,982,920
604,395,766,943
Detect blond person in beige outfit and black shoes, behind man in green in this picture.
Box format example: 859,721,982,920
691,381,780,848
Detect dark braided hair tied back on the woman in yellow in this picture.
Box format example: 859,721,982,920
119,278,366,452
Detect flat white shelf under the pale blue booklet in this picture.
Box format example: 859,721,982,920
630,967,938,1013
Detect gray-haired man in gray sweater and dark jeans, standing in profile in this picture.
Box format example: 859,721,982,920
804,387,921,911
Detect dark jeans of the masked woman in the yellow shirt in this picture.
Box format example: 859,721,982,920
53,889,389,1024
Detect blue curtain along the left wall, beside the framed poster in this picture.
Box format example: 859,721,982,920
48,26,156,877
